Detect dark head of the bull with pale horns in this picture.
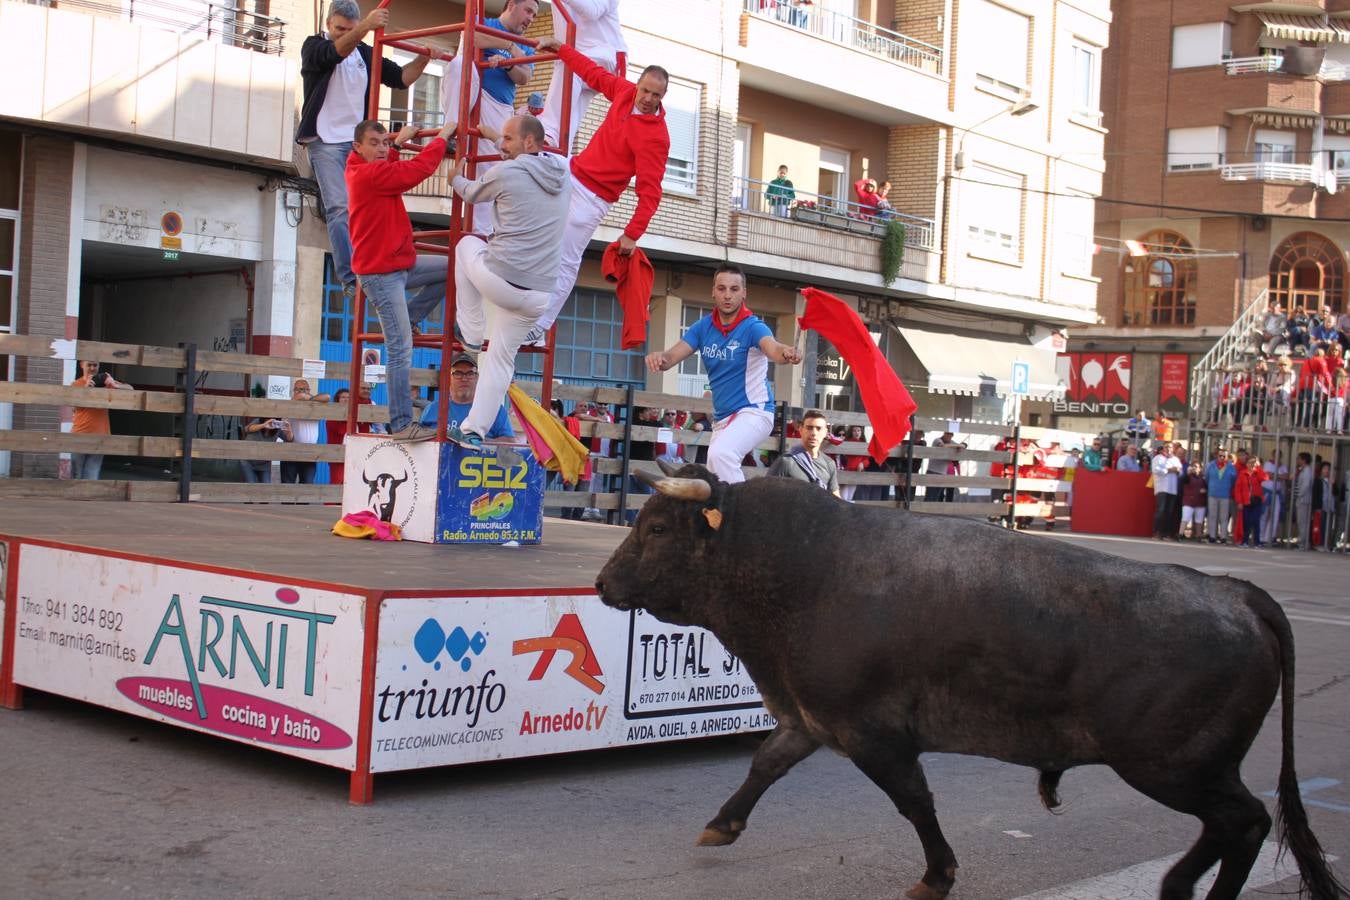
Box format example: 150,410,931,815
595,461,728,625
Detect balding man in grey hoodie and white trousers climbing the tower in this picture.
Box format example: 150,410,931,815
448,116,571,449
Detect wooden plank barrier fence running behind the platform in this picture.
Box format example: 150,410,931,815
0,335,1062,521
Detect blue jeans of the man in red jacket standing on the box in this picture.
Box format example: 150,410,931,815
360,254,448,432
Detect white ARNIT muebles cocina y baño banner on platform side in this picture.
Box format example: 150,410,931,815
14,544,365,769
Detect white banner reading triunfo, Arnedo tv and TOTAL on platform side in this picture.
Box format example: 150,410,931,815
371,595,775,772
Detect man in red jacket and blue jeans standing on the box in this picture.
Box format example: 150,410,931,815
347,120,455,441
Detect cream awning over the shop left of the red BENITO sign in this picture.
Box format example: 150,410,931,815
896,327,1064,401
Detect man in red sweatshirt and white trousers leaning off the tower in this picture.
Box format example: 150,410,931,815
524,38,671,344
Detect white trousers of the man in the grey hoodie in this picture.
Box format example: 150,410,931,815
455,235,548,436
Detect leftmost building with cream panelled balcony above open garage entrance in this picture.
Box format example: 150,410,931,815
0,0,301,475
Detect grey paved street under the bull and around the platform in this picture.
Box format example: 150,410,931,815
0,534,1350,900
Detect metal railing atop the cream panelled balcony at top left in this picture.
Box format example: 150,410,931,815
30,0,286,54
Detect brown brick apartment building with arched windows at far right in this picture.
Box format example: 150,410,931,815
1071,0,1350,424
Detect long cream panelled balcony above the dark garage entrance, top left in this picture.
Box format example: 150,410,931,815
0,0,298,167
